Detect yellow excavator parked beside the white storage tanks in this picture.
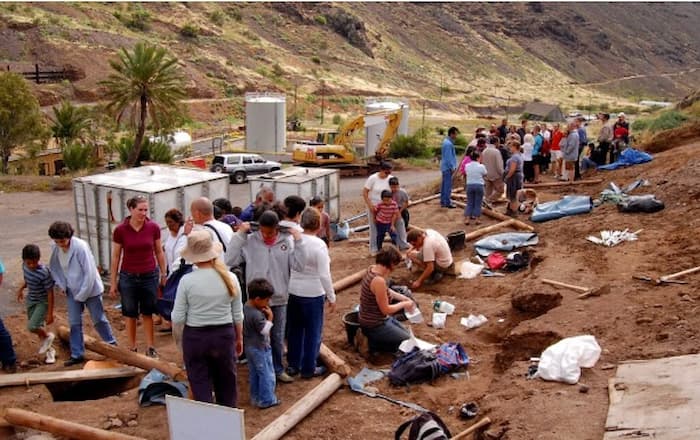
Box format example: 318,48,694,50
292,108,402,168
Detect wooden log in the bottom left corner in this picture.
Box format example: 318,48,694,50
5,408,143,440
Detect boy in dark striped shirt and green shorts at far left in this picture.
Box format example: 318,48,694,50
17,244,56,364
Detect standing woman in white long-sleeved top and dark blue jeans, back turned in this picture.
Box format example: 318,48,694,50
287,208,335,378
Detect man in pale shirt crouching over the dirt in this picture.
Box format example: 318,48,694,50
406,228,455,289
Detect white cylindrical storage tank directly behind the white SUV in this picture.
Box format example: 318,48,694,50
245,93,287,153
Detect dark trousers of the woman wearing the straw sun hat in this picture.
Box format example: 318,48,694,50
182,324,238,408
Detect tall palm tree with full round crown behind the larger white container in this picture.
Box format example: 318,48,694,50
100,42,185,167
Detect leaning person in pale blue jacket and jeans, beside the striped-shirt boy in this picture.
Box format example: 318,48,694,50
49,222,117,367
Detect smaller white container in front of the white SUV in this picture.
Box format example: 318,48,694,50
248,167,340,222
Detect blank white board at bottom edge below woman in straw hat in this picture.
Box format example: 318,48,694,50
165,395,245,440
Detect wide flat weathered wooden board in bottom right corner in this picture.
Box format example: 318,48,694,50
603,354,700,440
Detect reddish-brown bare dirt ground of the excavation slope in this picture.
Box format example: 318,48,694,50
0,141,700,440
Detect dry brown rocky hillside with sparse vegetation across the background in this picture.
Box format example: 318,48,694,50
0,3,700,117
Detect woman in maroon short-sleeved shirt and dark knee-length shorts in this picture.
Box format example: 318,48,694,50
109,196,168,358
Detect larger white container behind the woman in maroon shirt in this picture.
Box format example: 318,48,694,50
73,165,229,274
